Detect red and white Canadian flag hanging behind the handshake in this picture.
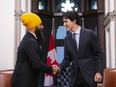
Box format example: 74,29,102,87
44,34,58,87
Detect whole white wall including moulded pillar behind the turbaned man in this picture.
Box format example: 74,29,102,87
0,0,31,70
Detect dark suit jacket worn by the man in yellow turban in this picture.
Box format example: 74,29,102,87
11,32,53,87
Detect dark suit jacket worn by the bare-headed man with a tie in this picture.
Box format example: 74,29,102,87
59,29,104,86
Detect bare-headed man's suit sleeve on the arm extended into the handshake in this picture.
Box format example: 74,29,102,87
59,38,72,70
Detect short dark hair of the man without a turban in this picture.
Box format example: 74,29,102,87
63,11,81,25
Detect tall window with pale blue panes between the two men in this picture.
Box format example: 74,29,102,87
54,18,67,63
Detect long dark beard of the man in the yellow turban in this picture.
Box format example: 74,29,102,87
35,27,45,43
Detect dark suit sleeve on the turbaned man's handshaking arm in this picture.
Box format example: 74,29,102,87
25,41,53,74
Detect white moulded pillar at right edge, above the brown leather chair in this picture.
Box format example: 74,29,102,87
104,0,116,68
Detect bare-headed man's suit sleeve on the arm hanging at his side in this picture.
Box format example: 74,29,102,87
90,31,104,74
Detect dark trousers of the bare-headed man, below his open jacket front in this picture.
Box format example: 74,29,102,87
73,68,97,87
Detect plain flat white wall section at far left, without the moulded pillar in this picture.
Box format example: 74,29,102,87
0,0,15,69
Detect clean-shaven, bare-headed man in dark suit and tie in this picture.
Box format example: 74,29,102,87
59,12,104,87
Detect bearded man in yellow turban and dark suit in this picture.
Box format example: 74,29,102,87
11,12,58,87
